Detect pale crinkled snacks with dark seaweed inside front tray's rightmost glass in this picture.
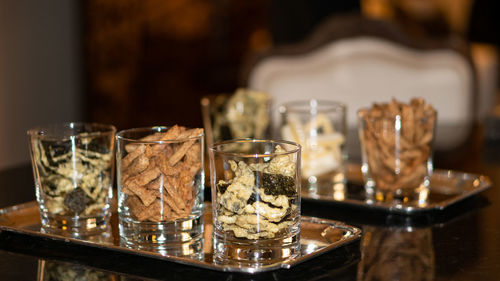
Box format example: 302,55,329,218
216,146,299,240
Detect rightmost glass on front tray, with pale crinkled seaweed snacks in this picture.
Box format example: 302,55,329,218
209,139,301,266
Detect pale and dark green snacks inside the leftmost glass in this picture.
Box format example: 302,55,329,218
33,133,113,216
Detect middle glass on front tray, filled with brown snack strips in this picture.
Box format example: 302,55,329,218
116,125,204,256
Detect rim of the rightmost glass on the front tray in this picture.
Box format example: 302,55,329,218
208,138,302,158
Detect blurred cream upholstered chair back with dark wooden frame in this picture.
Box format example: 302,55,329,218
242,16,477,158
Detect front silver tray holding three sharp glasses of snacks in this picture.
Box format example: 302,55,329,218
0,201,361,273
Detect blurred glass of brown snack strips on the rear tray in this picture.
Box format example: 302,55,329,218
358,98,436,203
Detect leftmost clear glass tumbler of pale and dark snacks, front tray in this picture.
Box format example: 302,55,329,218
28,123,116,236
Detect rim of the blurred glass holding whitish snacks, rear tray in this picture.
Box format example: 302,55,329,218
279,99,347,113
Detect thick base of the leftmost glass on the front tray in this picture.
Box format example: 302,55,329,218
41,214,109,238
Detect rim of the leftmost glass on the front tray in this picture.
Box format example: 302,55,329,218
26,122,116,139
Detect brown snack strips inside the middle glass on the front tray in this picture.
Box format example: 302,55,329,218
119,125,203,222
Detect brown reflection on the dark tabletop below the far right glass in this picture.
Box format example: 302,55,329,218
357,226,435,281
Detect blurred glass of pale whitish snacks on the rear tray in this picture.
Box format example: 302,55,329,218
279,99,347,193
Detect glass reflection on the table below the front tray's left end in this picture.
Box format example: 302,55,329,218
37,260,119,281
